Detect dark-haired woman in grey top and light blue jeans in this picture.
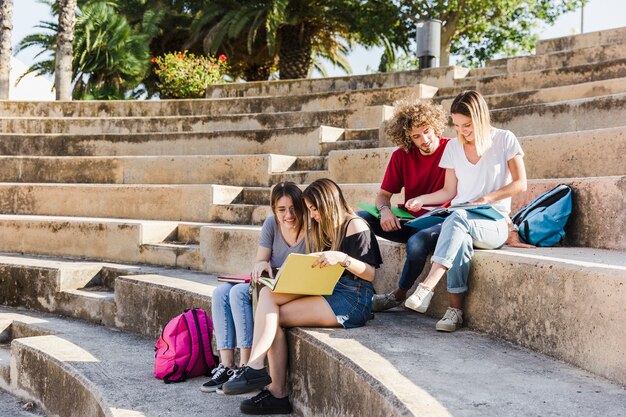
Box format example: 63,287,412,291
200,182,306,392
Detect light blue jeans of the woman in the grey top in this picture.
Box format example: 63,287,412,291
211,282,254,350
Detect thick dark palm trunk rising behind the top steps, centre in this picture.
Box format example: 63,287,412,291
278,23,313,80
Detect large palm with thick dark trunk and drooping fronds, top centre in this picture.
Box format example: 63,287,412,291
192,0,361,79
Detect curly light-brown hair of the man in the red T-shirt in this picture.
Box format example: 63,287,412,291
385,99,448,152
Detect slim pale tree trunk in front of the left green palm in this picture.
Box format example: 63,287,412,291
54,0,76,100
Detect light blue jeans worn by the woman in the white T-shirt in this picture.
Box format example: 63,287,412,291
431,210,509,294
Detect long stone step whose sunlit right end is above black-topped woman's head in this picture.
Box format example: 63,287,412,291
0,126,345,156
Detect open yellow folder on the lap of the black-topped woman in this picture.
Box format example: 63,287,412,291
259,253,344,295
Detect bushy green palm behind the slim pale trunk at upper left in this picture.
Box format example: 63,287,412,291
16,0,162,99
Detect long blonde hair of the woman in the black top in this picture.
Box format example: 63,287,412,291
303,178,355,252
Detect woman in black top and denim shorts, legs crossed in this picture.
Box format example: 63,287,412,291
223,178,382,414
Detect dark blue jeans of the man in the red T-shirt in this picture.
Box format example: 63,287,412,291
357,211,441,291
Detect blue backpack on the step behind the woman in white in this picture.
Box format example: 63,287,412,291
511,184,572,246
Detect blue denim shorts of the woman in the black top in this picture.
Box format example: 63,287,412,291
324,277,374,329
